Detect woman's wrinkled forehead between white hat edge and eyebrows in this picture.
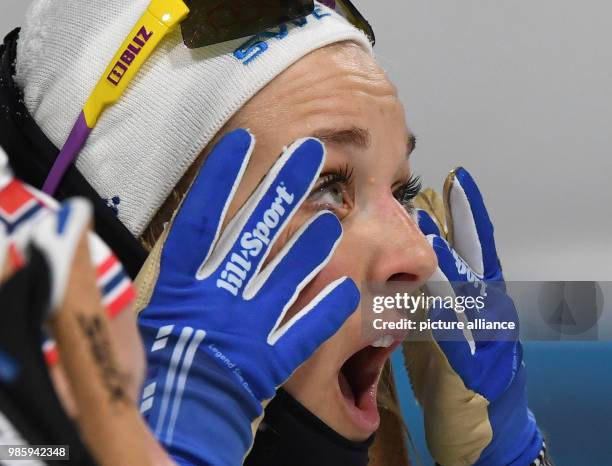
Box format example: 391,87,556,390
232,43,410,150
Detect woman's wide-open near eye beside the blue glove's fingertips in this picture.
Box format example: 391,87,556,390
308,166,353,219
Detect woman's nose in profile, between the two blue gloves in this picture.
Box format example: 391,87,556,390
368,198,437,289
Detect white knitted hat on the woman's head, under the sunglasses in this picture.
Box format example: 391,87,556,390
16,0,372,236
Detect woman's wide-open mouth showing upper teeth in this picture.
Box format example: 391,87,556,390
338,334,400,435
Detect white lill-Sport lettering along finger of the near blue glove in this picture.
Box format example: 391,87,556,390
217,181,295,296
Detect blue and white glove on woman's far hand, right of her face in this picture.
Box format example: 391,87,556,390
419,168,543,466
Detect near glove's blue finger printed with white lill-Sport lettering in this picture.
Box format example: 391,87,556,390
198,138,325,294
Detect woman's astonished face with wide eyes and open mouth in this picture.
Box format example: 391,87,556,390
220,43,436,440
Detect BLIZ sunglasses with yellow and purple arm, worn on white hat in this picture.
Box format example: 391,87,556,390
43,0,375,195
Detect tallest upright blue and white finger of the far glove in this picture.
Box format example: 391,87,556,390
444,167,501,279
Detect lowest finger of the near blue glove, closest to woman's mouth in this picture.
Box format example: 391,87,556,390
273,277,360,370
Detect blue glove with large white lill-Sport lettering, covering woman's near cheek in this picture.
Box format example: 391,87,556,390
139,130,359,465
